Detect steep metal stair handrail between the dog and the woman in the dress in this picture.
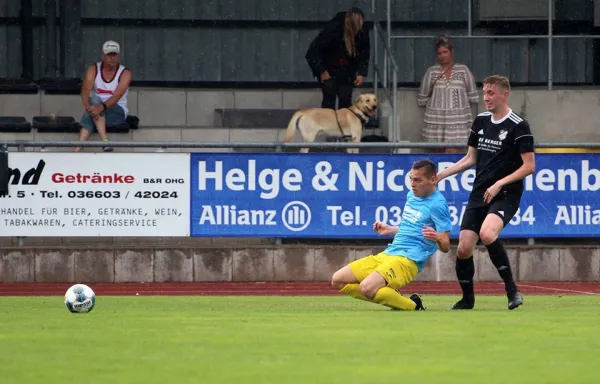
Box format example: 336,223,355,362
371,0,400,147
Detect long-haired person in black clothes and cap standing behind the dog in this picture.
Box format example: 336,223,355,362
306,7,370,109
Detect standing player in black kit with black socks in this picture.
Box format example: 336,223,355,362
437,76,535,310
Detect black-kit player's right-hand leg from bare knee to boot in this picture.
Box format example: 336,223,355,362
479,214,523,310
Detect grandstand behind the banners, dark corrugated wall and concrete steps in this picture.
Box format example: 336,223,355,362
0,0,600,151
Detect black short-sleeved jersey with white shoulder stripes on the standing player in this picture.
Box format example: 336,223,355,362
468,110,534,201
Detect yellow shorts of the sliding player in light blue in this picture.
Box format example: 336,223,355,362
348,252,419,289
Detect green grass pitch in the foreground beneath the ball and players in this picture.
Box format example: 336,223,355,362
0,295,600,384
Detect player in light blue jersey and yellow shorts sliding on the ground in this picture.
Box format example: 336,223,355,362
331,160,452,311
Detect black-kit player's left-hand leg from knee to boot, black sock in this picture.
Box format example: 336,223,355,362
451,230,478,309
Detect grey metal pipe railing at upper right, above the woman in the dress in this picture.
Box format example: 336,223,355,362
386,0,600,90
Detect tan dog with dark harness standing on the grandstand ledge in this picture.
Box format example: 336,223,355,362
284,93,377,153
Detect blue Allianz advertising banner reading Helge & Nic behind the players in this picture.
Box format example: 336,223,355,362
190,153,600,238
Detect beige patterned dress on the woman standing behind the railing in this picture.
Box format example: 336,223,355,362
417,64,479,143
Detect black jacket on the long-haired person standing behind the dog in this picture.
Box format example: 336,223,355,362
306,12,370,81
